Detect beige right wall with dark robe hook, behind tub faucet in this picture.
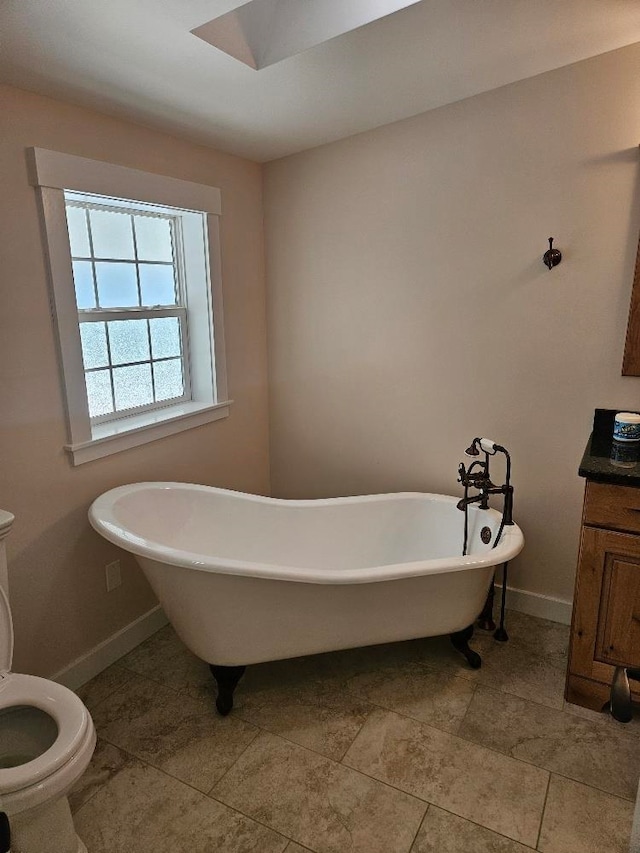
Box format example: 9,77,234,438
265,45,640,599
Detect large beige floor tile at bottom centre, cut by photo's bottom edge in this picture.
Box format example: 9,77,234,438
211,733,426,853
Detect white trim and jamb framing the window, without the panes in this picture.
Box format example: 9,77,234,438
28,148,232,465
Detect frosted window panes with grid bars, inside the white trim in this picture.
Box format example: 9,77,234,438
65,193,191,423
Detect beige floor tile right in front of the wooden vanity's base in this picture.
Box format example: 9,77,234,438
458,687,640,799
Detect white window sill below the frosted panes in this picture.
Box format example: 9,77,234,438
65,400,233,465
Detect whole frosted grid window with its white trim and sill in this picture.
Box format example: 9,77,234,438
30,149,230,464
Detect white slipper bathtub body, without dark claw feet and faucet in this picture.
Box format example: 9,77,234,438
89,483,524,684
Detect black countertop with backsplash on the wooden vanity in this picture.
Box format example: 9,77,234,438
578,409,640,487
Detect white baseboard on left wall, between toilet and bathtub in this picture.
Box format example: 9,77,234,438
51,604,169,690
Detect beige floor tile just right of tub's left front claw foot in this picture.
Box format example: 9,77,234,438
234,680,373,761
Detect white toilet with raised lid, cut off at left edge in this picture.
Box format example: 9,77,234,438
0,510,96,853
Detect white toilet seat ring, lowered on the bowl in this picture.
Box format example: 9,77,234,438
0,672,92,796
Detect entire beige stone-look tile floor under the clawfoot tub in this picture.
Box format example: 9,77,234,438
71,613,640,853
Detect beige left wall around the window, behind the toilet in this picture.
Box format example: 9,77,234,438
0,87,269,675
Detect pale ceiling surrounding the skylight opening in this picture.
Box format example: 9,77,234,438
0,0,640,161
